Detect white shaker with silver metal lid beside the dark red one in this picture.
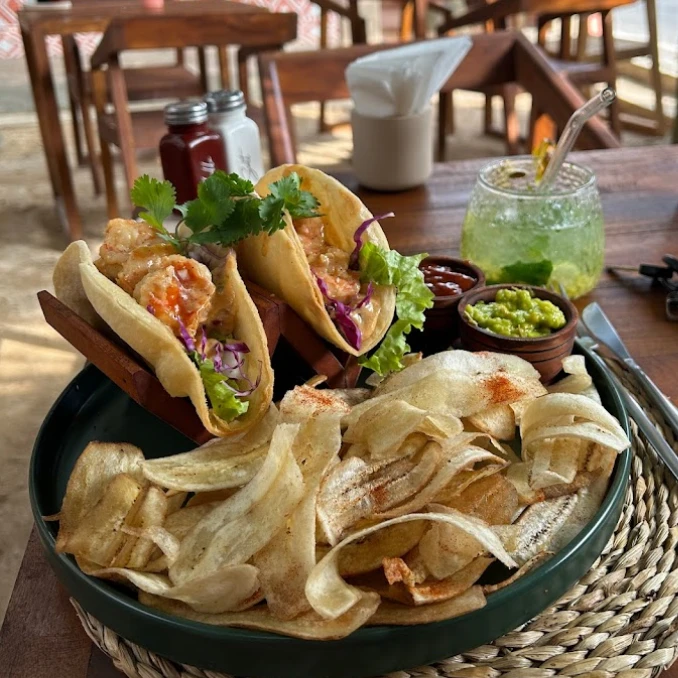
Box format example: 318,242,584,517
205,90,264,182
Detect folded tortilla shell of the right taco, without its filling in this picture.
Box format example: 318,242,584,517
238,165,395,355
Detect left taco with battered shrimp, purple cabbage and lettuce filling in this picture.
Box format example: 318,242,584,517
54,219,273,436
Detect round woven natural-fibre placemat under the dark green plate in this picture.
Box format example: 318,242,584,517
72,366,678,678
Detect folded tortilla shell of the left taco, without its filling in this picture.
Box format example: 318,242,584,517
54,240,273,436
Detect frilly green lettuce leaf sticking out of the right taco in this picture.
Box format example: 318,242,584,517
360,242,433,377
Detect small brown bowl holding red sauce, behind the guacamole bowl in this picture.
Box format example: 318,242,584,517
408,255,485,355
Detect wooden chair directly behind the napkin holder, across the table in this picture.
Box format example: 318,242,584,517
259,32,619,166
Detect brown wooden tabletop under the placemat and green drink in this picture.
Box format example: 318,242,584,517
0,146,678,678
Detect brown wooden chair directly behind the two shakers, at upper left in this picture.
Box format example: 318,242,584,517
92,11,297,217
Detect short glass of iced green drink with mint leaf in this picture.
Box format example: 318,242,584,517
461,158,605,299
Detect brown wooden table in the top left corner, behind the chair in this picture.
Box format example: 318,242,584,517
18,0,268,239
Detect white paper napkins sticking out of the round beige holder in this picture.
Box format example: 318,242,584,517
346,36,472,118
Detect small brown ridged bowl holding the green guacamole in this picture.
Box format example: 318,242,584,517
457,285,579,384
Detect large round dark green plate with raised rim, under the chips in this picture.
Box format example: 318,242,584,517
30,348,631,678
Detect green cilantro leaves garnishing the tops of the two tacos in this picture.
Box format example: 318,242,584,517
131,171,326,251
